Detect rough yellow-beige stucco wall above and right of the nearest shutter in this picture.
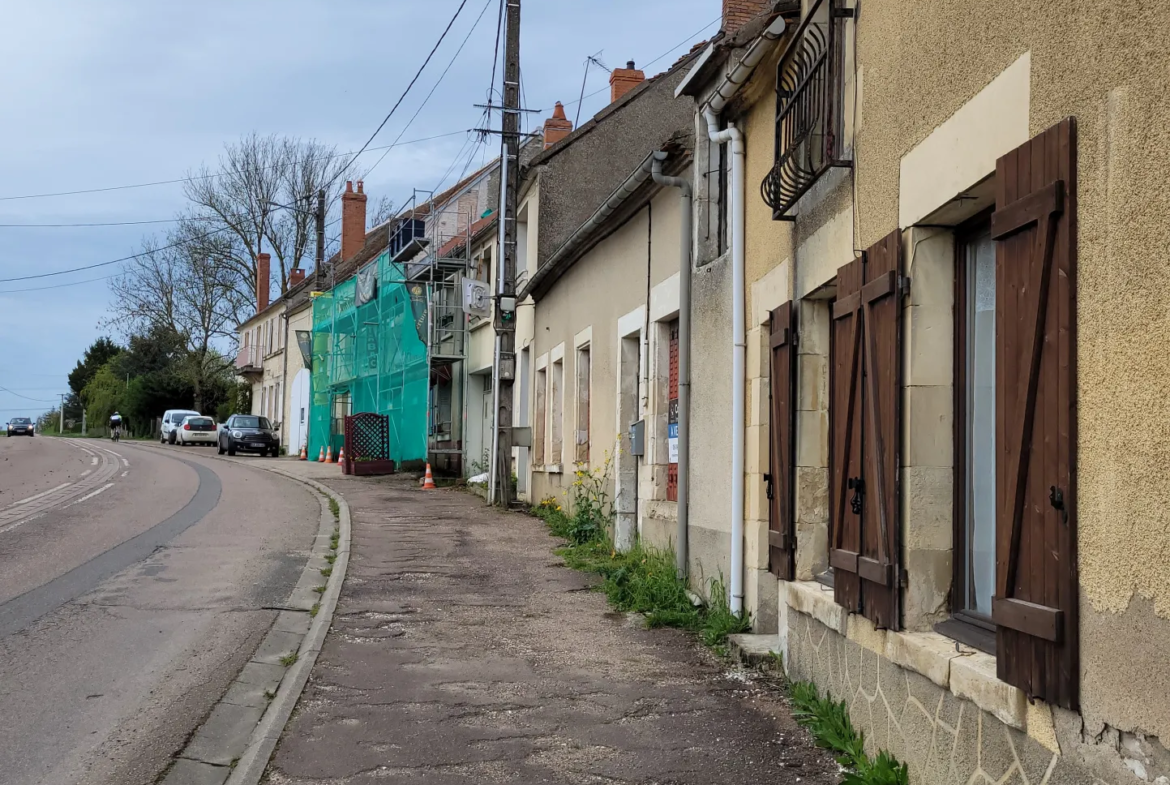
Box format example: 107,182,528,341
856,0,1170,739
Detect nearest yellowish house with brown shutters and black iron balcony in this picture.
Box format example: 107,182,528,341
679,0,1170,784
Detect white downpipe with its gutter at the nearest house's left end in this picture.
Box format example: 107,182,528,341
679,10,786,615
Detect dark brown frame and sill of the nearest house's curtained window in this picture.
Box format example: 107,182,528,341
935,207,999,655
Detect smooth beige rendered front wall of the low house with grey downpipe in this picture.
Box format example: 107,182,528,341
521,190,680,524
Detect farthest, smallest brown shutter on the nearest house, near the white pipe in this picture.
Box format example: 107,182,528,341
768,301,797,580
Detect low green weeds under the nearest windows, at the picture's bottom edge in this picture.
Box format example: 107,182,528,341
789,681,910,785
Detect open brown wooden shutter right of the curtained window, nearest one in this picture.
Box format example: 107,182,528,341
991,118,1080,709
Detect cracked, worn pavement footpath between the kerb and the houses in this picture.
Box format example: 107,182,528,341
264,461,838,785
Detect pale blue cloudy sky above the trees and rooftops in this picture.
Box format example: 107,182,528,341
0,0,722,422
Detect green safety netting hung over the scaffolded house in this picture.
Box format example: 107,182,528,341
309,253,428,463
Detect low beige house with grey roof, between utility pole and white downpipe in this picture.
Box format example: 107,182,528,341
515,56,693,548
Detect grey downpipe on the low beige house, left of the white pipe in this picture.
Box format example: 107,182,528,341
651,152,694,579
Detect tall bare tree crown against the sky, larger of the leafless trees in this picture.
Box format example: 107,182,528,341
184,133,346,299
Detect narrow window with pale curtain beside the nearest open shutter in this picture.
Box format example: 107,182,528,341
951,215,996,650
